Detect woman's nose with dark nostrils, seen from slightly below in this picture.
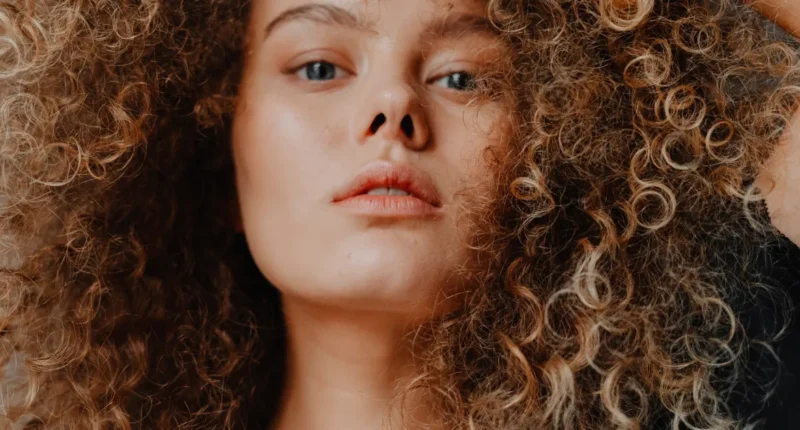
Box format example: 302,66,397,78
359,82,430,151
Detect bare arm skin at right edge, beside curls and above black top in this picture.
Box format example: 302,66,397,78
756,107,800,246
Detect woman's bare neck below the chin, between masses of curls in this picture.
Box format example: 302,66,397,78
273,295,434,430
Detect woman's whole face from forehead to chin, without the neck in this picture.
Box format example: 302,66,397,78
233,0,502,314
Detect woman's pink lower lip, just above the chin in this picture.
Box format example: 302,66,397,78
334,194,442,217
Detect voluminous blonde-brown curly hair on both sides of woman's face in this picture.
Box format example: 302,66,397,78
0,0,800,429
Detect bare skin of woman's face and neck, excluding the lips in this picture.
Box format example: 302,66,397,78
233,0,502,430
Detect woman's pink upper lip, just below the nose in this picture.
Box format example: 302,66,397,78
333,160,441,207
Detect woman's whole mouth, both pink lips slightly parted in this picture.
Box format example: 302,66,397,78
332,160,442,216
